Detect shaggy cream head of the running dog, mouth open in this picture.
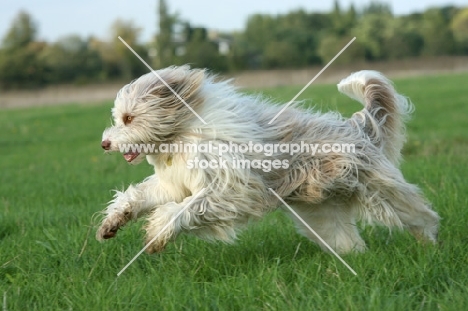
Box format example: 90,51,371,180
101,66,205,164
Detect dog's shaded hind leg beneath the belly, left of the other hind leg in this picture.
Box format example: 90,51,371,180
289,199,366,254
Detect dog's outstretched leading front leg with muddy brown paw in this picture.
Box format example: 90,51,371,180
96,176,177,240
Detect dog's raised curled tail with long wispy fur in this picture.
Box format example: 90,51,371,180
338,70,413,165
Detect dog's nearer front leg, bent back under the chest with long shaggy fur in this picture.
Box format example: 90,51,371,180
145,186,272,254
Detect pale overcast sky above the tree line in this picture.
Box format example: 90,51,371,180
0,0,468,41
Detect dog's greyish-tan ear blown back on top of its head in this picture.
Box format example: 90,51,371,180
147,66,205,101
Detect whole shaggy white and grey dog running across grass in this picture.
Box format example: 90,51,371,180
97,66,439,253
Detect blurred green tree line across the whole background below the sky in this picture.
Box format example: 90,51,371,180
0,0,468,88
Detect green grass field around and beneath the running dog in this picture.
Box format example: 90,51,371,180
0,74,468,310
